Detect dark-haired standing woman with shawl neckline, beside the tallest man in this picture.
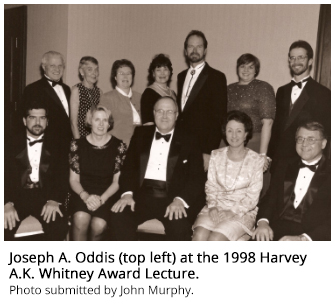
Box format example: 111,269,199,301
141,53,176,125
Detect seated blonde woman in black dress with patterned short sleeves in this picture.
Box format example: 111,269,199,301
70,106,127,241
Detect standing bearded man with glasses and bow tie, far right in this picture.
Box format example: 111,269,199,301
268,40,331,171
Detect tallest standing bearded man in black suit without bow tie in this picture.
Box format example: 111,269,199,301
177,30,227,171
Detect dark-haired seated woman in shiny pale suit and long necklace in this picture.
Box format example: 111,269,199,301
193,111,264,241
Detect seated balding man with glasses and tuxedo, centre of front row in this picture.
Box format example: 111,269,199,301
110,97,206,240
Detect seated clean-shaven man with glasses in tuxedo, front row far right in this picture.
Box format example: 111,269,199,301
253,121,331,241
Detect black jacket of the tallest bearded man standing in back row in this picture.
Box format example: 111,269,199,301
177,63,227,154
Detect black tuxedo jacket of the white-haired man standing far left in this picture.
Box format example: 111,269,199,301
23,77,72,154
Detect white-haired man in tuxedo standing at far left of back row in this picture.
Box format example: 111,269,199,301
23,51,72,155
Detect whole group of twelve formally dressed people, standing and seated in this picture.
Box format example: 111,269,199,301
4,30,331,241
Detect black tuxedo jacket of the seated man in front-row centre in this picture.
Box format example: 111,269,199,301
120,126,206,223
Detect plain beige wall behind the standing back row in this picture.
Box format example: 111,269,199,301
6,4,320,92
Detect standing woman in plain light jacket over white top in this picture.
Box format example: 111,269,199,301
99,59,141,145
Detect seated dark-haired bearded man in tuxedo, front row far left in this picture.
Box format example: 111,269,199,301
4,101,69,240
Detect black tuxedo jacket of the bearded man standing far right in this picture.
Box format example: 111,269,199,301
268,79,331,168
